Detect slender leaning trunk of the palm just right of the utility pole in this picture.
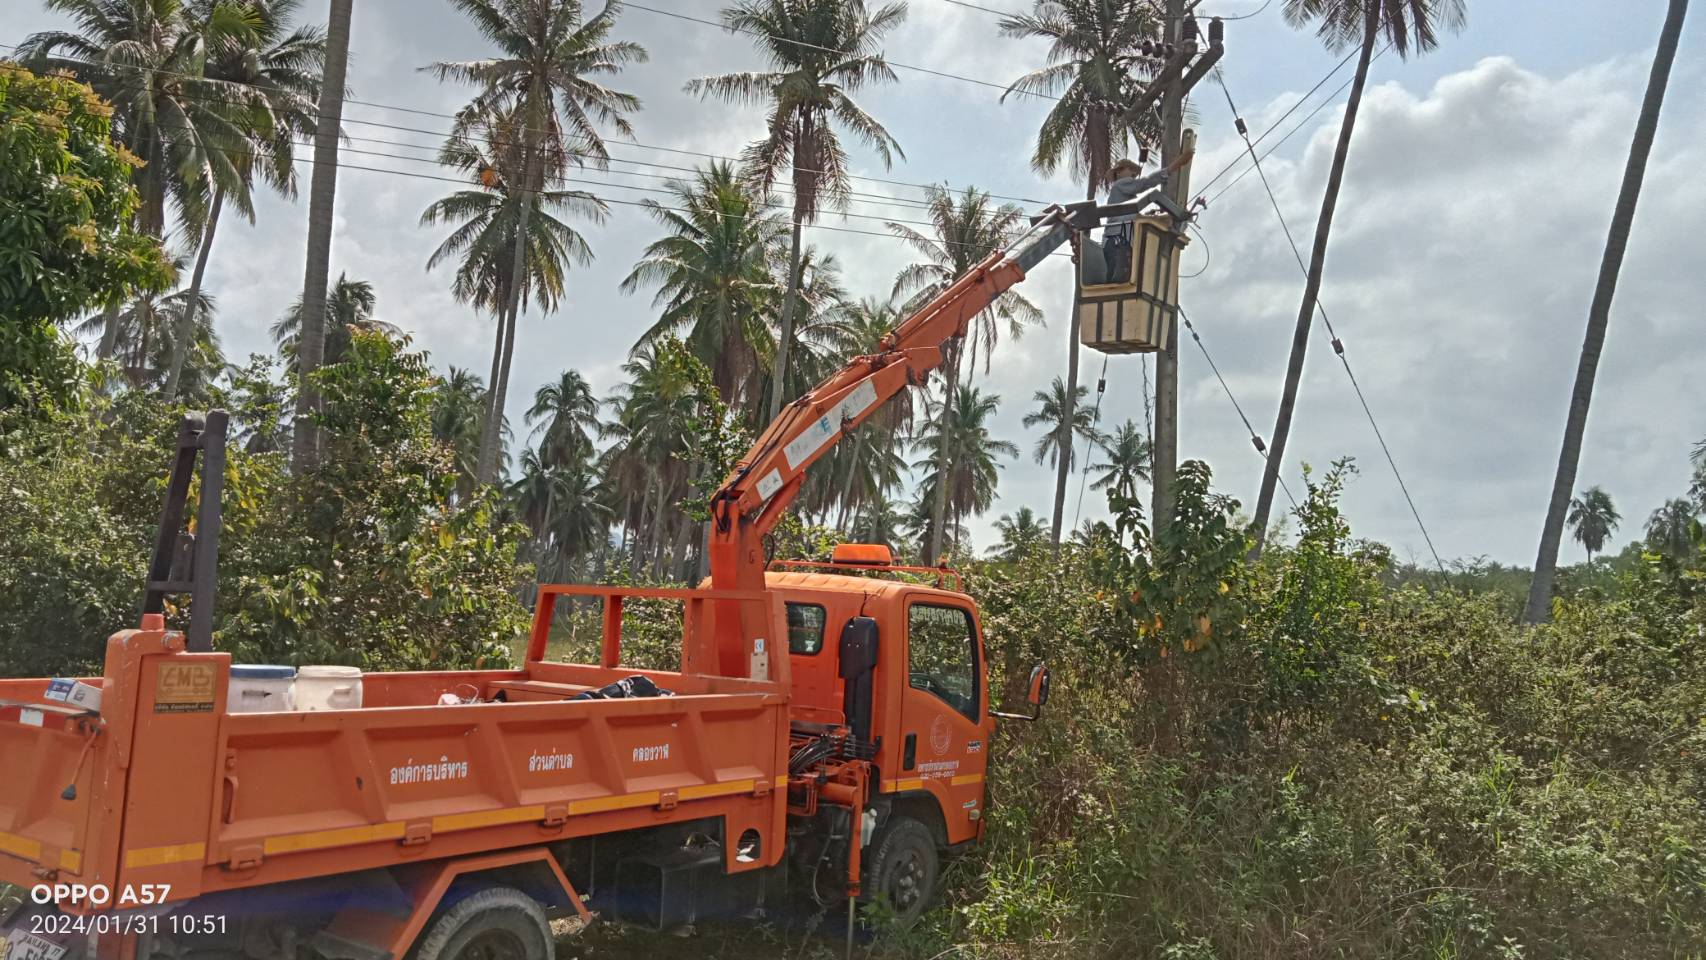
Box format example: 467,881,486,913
1250,3,1380,559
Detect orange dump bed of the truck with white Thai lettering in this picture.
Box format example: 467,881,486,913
0,587,788,912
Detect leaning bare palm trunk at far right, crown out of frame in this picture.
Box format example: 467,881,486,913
1522,0,1689,624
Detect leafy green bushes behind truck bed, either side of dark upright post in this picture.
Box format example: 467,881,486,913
0,334,531,675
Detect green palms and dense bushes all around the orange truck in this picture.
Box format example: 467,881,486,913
0,0,1706,960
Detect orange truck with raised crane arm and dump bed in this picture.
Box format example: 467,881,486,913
0,193,1169,960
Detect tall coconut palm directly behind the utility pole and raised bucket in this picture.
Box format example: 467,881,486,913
1001,0,1162,549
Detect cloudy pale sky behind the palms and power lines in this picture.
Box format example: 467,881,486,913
0,0,1706,564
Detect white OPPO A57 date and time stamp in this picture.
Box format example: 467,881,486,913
0,883,229,960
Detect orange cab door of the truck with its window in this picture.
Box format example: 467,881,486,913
897,597,991,842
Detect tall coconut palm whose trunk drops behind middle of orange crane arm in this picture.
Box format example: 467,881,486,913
686,0,906,421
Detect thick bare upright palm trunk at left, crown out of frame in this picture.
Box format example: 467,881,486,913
292,0,355,472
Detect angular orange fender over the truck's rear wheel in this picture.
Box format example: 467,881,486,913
312,847,590,960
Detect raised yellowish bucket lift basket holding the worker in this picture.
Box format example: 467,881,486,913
1078,217,1189,353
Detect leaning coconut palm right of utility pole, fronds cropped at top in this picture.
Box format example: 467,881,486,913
1252,0,1473,552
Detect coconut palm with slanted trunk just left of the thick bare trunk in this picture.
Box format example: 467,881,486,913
162,0,326,399
